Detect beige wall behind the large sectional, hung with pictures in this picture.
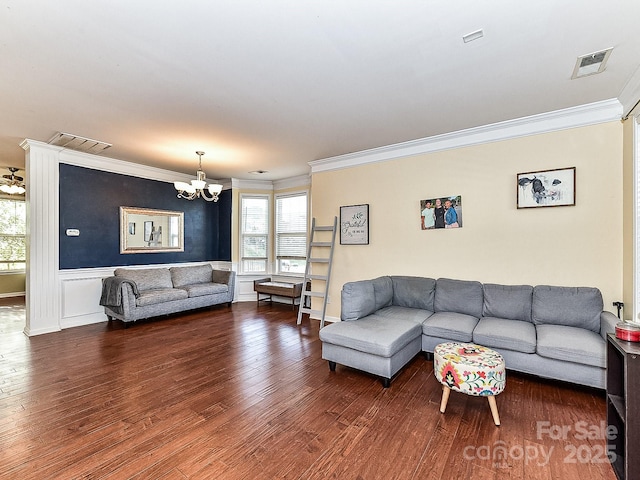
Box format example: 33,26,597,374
312,122,623,317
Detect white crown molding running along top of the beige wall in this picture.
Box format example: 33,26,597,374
309,99,622,174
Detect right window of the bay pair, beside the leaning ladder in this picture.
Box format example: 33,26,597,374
275,192,308,274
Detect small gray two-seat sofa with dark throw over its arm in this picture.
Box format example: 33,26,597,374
100,264,235,326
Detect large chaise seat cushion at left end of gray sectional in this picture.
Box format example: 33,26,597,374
320,314,422,358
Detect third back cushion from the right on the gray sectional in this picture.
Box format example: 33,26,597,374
434,278,483,318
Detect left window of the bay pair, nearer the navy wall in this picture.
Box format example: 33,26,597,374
240,195,269,273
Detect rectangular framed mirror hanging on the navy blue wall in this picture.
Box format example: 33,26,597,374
120,207,184,253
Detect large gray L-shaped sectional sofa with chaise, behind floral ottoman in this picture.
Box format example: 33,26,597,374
320,276,618,389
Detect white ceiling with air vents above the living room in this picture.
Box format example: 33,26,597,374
0,0,640,180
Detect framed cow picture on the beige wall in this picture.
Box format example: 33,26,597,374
517,167,576,208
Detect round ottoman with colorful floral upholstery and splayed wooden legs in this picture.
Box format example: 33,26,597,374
433,342,506,425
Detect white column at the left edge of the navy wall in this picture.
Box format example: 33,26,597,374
21,139,61,336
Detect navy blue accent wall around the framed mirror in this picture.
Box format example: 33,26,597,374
60,164,232,269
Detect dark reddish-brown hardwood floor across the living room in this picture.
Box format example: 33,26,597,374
0,302,615,480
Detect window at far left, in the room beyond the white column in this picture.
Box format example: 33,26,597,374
0,198,27,271
